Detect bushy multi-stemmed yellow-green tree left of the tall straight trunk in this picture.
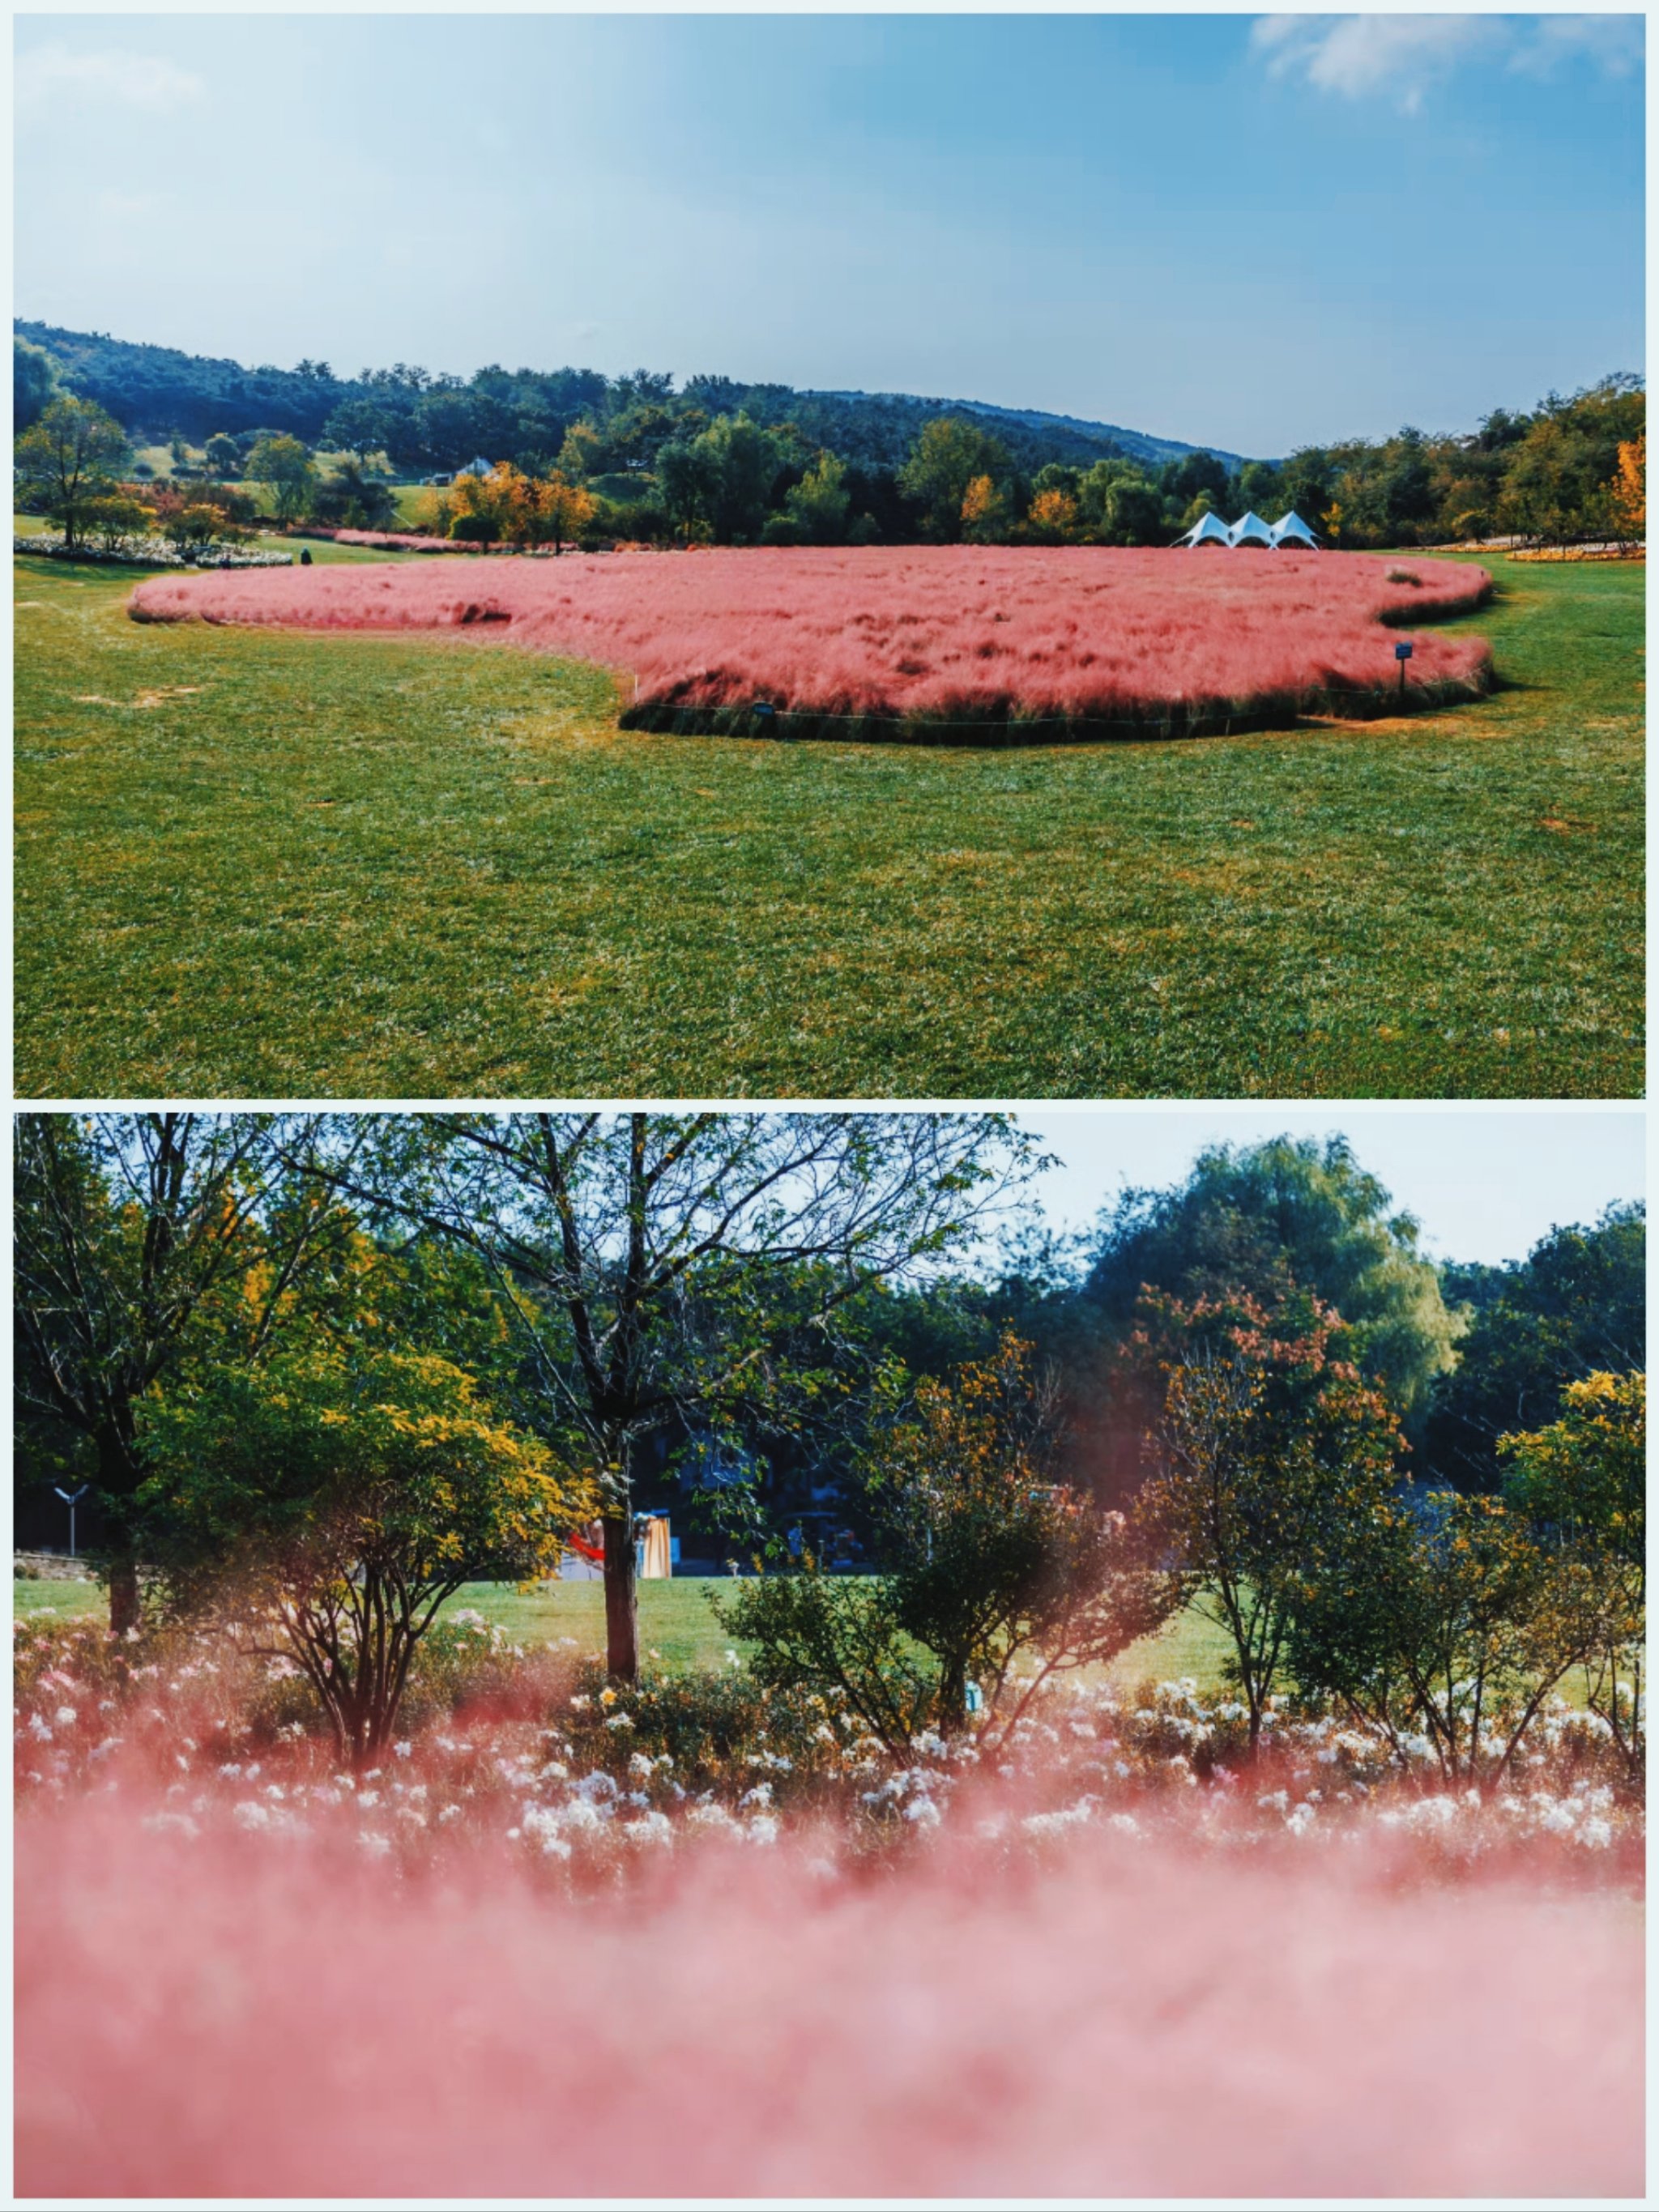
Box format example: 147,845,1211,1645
137,1332,593,1765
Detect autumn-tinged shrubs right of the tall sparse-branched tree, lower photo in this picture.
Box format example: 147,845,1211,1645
739,1294,1646,1783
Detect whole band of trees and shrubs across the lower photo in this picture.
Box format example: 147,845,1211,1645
15,1113,1644,1772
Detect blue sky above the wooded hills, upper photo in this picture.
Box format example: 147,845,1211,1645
13,13,1644,454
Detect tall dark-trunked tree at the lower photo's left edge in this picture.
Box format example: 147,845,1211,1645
13,1113,362,1634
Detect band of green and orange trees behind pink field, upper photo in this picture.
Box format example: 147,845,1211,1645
13,339,1646,547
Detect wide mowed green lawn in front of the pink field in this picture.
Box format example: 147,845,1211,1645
15,555,1646,1097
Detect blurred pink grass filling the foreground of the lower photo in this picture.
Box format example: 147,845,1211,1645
15,1801,1644,2203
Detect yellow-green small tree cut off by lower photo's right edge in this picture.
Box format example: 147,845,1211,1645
1498,1374,1648,1774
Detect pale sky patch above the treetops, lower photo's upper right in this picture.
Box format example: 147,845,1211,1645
1020,1104,1646,1265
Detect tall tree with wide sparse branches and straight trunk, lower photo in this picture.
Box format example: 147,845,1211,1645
318,1113,1029,1681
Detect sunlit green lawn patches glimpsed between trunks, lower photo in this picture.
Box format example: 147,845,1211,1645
11,1575,1228,1688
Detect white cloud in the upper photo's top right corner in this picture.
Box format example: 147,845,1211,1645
1250,15,1644,115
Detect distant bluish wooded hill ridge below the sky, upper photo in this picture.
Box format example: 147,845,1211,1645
13,317,1241,469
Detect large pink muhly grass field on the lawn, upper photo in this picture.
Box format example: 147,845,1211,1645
130,547,1491,736
